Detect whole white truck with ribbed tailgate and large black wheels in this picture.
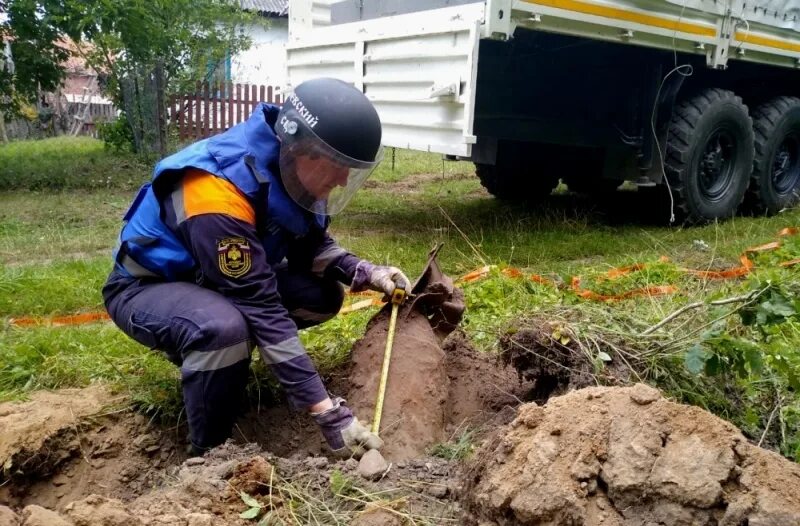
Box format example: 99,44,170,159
286,0,800,223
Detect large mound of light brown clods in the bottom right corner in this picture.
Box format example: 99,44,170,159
464,384,800,526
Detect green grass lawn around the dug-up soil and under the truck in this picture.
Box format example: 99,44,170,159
0,141,800,457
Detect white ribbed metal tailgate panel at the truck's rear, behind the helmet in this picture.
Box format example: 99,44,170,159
287,2,485,156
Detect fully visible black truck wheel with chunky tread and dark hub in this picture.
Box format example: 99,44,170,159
664,88,754,223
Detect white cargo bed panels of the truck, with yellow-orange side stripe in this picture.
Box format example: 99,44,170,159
287,0,800,157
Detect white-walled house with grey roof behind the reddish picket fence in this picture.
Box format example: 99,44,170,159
233,0,289,88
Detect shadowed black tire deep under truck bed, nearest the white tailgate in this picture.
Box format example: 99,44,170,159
475,141,558,201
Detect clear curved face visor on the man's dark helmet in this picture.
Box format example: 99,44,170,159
278,115,383,216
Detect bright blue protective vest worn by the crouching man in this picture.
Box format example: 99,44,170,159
115,103,328,281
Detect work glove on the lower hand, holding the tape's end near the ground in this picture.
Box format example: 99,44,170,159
311,397,383,458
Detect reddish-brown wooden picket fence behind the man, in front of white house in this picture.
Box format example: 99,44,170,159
169,82,283,140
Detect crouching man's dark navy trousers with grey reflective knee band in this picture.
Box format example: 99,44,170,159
103,266,344,449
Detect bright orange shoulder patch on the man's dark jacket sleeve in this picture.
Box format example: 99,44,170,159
183,168,256,225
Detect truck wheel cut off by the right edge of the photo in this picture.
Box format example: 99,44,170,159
747,97,800,214
